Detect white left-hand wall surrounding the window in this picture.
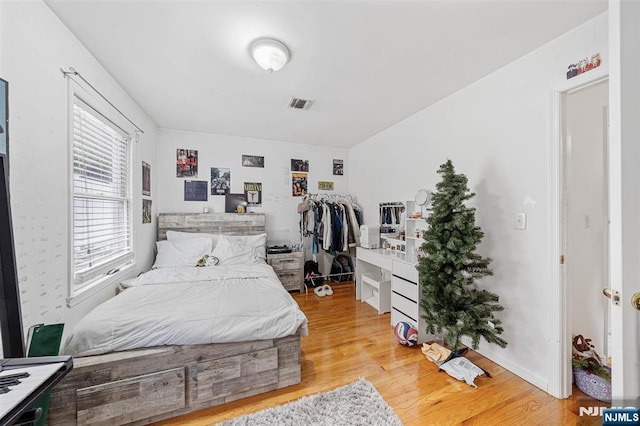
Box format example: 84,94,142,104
0,1,157,352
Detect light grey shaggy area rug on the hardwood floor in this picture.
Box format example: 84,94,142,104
218,379,402,426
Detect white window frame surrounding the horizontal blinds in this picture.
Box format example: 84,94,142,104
66,77,136,307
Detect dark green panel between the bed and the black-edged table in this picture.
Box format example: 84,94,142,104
27,324,64,426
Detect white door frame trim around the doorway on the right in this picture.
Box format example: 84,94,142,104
546,69,608,399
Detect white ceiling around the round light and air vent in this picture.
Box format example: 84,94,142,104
46,0,607,147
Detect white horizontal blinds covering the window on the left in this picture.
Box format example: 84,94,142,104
72,96,133,290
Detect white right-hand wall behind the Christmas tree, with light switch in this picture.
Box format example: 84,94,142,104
349,14,608,389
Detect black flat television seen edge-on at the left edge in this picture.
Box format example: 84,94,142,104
0,154,25,358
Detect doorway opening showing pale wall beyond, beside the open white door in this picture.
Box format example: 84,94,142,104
561,80,611,392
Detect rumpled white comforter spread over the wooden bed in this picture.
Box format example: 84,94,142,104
64,264,307,356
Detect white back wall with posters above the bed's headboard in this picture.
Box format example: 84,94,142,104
156,129,349,241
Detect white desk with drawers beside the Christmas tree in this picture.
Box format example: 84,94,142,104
356,247,434,343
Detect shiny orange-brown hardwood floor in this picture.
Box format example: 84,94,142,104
157,283,606,426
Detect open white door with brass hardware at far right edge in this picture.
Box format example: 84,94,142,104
609,0,640,407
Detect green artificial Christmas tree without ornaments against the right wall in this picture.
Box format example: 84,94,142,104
417,160,507,356
